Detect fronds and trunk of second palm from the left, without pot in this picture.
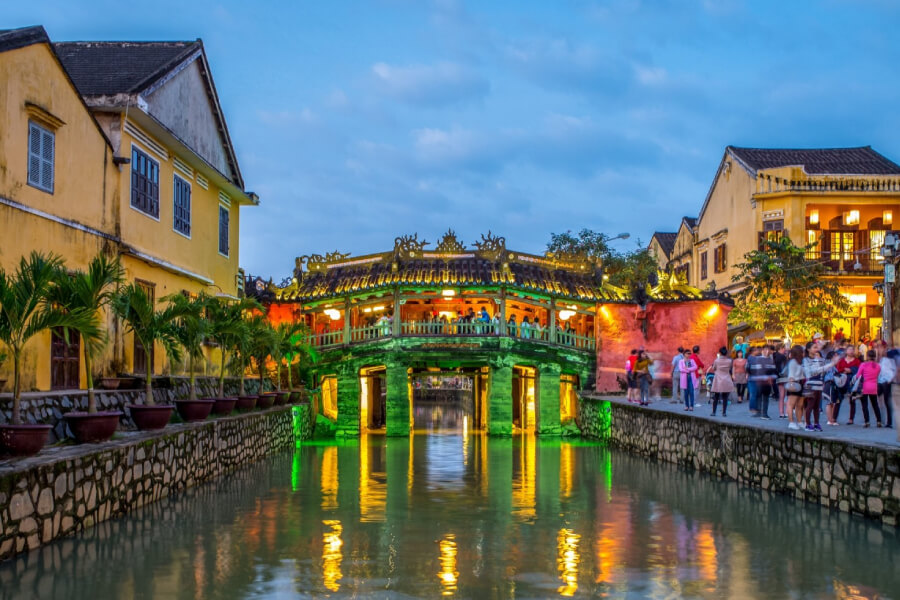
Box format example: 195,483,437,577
50,253,123,413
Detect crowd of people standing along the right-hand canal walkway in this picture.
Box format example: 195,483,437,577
625,334,900,440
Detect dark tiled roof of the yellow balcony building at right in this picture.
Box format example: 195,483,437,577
728,146,900,175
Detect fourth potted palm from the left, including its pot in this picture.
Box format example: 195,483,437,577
164,294,215,422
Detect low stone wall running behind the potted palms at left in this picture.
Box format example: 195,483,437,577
0,377,271,444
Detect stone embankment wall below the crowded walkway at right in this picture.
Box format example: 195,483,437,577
578,397,900,525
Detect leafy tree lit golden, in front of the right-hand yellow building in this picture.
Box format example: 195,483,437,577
729,236,850,338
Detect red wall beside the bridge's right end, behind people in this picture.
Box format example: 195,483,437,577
596,300,731,392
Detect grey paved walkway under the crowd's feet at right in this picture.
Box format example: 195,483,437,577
602,392,900,448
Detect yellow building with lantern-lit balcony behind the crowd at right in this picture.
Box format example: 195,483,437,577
669,146,900,339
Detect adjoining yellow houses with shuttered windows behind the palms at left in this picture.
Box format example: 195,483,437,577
0,27,258,390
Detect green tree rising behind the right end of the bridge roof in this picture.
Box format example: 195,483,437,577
547,229,659,298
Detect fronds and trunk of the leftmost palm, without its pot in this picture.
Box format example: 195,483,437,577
0,252,95,425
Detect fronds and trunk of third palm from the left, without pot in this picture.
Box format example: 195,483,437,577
112,283,181,406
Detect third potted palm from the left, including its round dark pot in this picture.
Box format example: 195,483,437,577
112,283,181,430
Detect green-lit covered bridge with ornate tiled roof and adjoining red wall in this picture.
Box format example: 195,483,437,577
245,231,727,435
